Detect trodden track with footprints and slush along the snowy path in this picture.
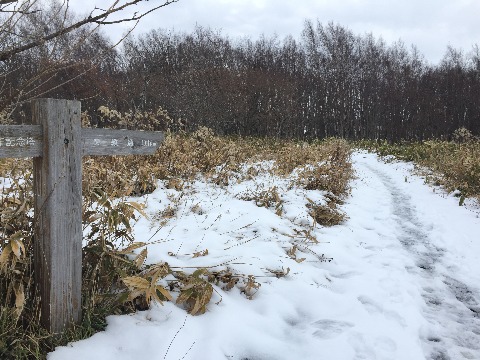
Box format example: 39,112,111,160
356,156,480,360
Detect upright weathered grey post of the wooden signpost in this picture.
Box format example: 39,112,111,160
32,99,82,332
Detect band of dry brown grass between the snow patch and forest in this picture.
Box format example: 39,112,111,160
83,128,353,197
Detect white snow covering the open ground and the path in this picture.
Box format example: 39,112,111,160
48,153,480,360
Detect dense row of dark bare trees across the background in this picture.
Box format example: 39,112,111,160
0,19,480,141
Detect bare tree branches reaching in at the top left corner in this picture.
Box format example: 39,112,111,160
0,0,178,117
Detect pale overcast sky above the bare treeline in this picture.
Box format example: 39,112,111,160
71,0,480,64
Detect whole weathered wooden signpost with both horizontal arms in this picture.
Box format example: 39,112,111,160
0,99,164,333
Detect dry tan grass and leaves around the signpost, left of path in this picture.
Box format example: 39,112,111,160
0,128,353,359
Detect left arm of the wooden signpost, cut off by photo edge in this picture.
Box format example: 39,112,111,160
0,125,43,158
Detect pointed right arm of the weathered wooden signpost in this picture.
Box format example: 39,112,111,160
82,128,164,155
